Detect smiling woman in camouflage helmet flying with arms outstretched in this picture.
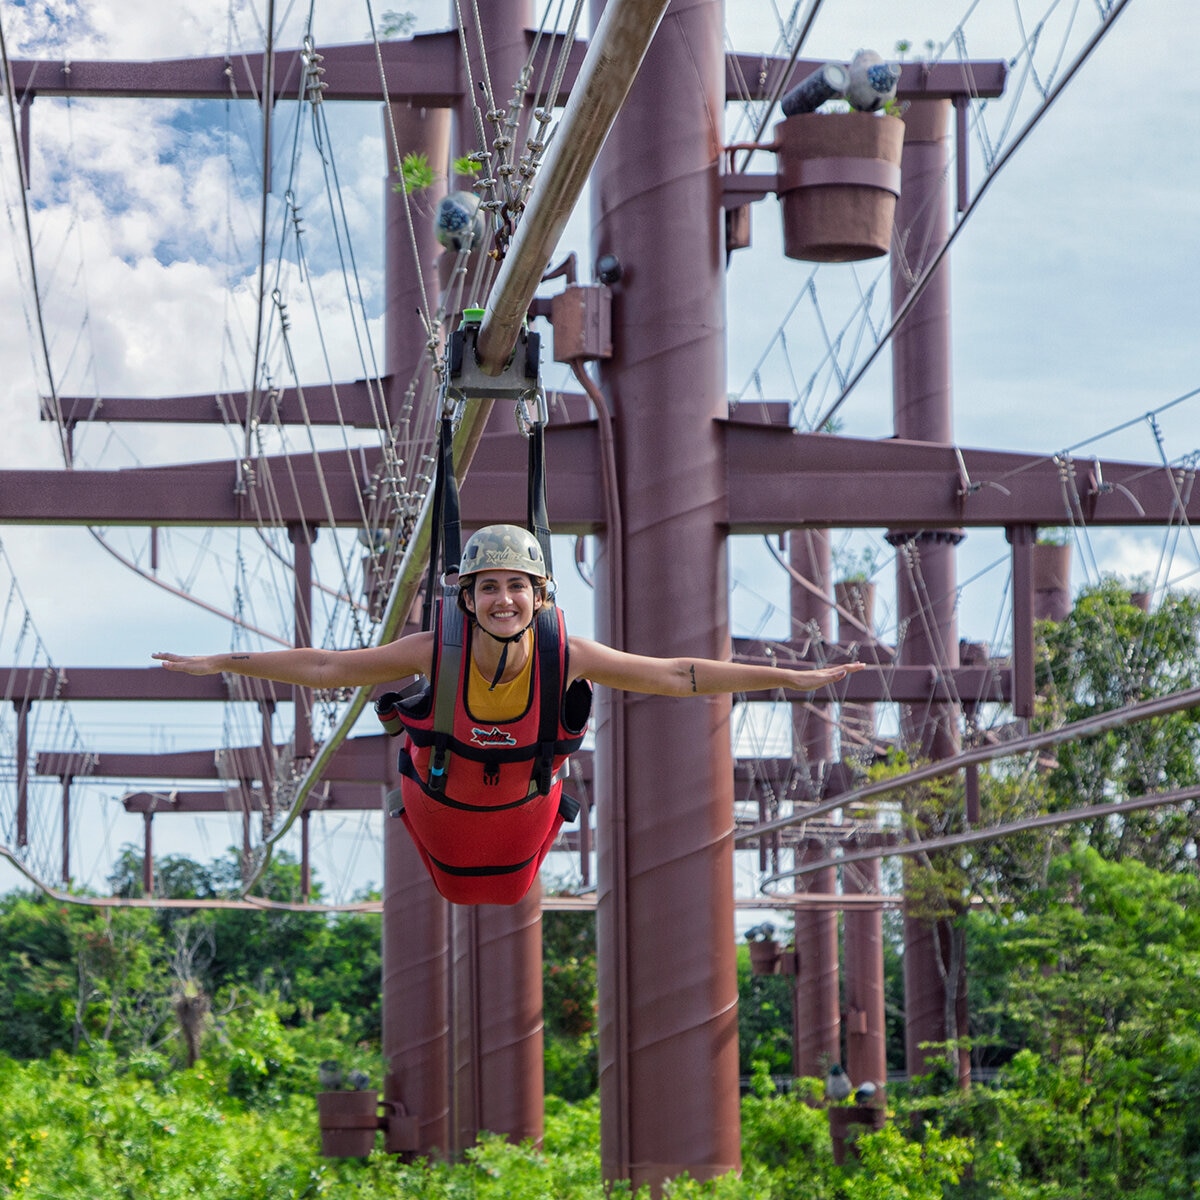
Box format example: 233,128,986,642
154,524,863,905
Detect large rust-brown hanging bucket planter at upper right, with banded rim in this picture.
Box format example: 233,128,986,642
775,113,904,263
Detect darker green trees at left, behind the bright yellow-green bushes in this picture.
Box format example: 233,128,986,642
0,856,380,1061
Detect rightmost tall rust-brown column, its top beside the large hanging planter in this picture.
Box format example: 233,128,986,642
889,101,970,1075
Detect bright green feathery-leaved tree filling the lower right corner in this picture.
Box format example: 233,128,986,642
966,842,1200,1200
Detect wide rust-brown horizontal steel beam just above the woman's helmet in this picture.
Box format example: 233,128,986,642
0,420,1200,534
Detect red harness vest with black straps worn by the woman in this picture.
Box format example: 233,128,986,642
376,607,592,905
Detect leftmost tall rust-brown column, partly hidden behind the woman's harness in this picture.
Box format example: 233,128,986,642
382,104,450,1154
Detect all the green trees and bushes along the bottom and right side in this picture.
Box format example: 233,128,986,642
7,582,1200,1200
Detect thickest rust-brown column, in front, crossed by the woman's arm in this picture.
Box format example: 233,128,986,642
593,0,740,1190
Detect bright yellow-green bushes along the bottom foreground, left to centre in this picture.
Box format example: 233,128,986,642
0,1036,967,1200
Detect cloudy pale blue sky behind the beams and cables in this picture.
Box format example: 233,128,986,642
0,0,1200,886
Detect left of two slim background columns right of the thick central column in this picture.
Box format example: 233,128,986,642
787,529,841,1078
